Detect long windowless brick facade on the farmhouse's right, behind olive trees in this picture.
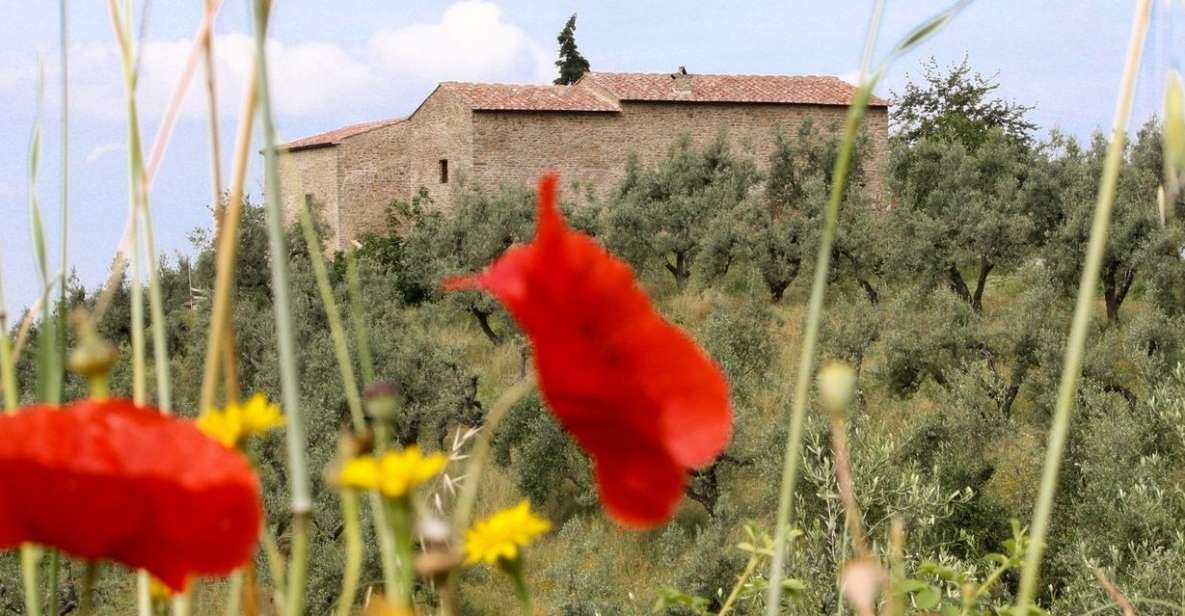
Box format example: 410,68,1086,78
472,102,888,203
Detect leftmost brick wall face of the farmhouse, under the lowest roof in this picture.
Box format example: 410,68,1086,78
273,146,340,250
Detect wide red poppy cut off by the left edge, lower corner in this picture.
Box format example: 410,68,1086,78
0,399,262,590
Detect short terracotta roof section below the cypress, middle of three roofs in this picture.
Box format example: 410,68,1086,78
440,82,621,111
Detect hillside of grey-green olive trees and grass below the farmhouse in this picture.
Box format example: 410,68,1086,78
13,58,1185,615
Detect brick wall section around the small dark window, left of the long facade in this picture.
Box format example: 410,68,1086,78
338,90,473,249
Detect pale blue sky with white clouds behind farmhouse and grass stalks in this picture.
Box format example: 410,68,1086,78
0,0,1185,314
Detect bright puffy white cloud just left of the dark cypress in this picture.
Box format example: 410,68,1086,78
369,0,551,82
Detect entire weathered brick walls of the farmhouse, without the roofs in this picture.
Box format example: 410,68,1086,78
281,90,889,250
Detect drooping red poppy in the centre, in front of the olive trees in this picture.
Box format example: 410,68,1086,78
446,175,731,527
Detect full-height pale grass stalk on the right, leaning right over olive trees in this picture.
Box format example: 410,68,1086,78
1013,0,1152,615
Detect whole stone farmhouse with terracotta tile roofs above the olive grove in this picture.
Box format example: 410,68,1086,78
281,66,888,250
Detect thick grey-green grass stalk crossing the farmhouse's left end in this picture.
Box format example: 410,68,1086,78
252,0,313,616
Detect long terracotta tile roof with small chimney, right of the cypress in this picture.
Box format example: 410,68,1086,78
581,72,888,107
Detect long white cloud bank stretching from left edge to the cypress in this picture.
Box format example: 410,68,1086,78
0,0,553,121
